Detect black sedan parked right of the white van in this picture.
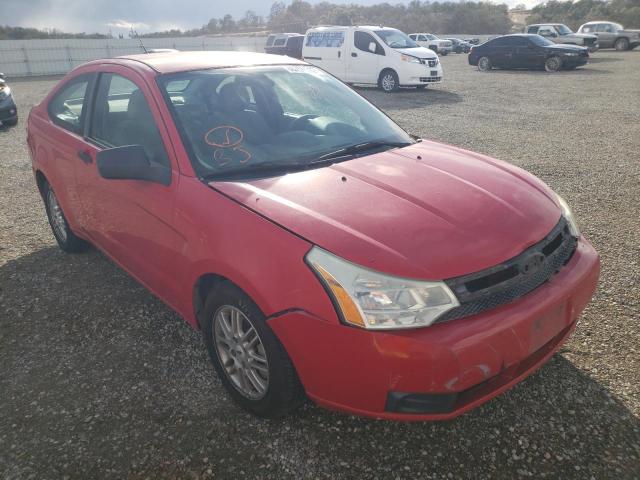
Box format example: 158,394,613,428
469,34,589,72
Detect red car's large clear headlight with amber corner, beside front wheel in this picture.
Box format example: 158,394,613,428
306,247,460,330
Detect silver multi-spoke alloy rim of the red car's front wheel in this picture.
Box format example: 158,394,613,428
213,305,269,400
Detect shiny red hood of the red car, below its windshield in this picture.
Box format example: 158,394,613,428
209,141,561,279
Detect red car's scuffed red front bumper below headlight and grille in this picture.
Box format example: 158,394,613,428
269,238,600,421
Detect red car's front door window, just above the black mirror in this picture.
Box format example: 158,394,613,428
89,73,169,165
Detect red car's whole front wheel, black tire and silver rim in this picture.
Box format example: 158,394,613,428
201,282,305,418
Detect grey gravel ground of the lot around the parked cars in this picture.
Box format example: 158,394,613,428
0,50,640,479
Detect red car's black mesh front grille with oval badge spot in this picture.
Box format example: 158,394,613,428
436,217,578,323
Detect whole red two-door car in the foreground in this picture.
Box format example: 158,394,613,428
28,52,599,420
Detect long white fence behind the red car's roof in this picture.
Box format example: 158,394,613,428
0,36,266,77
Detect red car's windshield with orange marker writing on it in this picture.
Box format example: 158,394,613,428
158,65,414,178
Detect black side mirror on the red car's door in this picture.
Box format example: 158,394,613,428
96,145,171,185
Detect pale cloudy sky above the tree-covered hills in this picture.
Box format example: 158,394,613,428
0,0,542,35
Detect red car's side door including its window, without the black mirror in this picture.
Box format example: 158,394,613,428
76,66,186,300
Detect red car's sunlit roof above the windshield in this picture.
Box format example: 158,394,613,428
90,51,306,74
